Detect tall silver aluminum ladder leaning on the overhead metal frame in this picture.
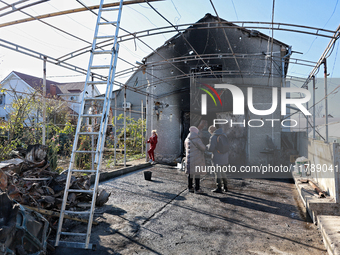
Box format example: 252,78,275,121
55,0,123,250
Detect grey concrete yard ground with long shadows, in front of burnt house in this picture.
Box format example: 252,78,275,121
55,165,327,255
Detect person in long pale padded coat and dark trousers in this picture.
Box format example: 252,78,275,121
184,126,206,194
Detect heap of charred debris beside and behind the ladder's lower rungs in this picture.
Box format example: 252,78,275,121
0,145,111,233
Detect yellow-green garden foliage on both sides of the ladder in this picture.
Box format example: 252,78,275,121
0,83,146,171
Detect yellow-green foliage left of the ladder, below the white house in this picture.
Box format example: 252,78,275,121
0,86,74,170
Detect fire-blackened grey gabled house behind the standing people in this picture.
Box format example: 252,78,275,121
112,14,291,165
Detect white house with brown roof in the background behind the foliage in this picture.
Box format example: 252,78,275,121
0,71,100,120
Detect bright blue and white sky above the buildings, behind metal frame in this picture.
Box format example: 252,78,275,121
0,0,340,117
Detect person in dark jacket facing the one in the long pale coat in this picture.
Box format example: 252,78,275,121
207,126,229,193
